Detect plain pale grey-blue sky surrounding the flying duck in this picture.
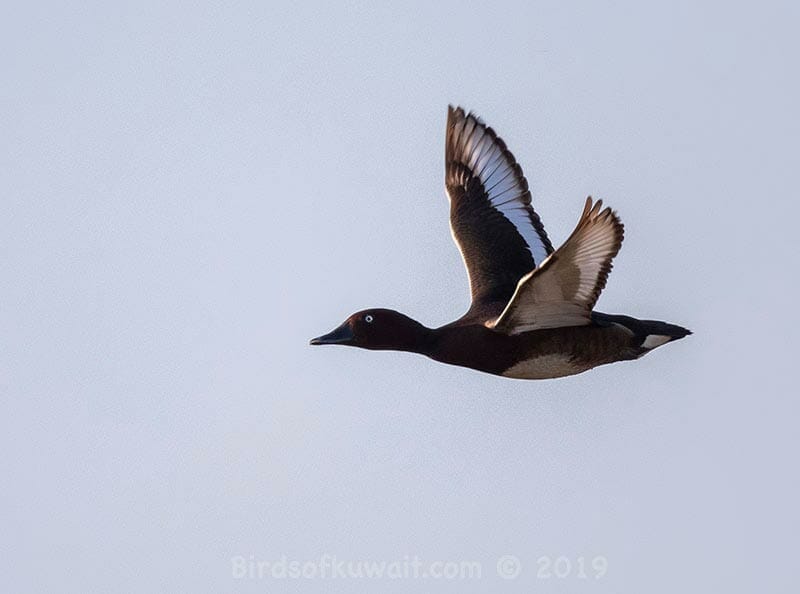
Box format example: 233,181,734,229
0,2,800,594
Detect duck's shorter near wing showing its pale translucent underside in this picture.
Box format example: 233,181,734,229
491,197,623,334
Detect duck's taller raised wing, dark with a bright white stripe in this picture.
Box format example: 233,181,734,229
445,106,553,306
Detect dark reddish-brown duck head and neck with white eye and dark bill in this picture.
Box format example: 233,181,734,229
310,309,432,352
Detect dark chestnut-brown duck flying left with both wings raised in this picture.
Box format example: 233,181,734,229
311,106,691,379
